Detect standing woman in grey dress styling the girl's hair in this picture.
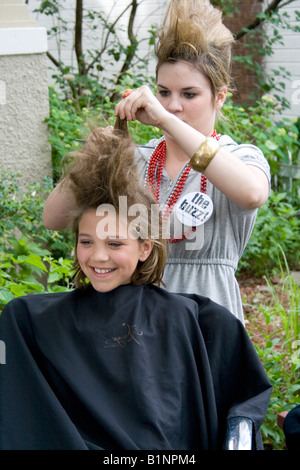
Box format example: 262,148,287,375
44,0,270,322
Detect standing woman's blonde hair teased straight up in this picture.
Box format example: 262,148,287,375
155,0,234,97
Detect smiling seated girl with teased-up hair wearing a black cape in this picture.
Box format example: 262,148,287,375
0,129,271,451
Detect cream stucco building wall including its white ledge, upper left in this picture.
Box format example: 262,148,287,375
0,0,52,185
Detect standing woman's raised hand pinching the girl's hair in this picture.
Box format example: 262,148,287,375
114,85,169,127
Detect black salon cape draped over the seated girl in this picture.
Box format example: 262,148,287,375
0,285,271,450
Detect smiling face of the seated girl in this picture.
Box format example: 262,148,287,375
76,209,152,292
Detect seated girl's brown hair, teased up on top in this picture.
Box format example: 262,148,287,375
62,120,167,288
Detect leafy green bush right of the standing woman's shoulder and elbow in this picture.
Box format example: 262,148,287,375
218,95,300,276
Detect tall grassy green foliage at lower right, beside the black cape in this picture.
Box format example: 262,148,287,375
246,252,300,450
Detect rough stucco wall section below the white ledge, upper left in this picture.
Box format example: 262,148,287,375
0,53,52,183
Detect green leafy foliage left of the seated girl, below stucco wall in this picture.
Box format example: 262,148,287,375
0,172,74,308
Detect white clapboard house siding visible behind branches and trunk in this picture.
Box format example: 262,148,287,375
28,0,300,117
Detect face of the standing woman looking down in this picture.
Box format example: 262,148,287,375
157,62,226,135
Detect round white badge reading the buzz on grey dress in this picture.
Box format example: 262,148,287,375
174,191,214,227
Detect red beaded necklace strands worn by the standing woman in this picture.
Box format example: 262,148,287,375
146,129,220,243
